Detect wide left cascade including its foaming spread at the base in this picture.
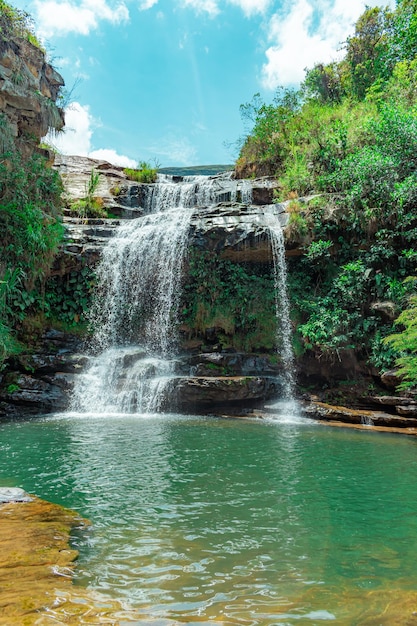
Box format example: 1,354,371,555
73,209,192,413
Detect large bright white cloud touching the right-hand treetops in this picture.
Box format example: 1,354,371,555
261,0,394,89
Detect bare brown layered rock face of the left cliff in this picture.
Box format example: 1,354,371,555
0,34,64,154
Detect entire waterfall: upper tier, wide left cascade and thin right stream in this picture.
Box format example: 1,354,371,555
72,174,295,413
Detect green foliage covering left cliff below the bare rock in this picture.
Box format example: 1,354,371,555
0,152,63,364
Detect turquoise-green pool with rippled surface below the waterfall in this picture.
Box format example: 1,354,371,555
0,415,417,625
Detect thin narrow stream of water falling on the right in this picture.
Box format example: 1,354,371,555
264,207,295,401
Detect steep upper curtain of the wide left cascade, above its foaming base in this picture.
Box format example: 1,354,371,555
92,209,192,358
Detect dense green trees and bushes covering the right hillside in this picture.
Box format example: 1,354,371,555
236,0,417,388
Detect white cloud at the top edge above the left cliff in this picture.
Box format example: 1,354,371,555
35,0,129,37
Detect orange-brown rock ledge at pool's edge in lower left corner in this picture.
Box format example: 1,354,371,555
0,487,140,626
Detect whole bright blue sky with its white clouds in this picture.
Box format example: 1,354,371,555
11,0,394,167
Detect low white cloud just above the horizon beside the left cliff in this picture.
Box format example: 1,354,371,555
45,102,136,167
